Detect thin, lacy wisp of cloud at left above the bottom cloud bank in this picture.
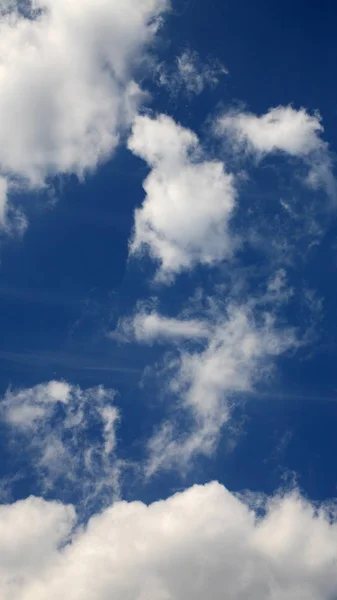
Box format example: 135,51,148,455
0,381,120,505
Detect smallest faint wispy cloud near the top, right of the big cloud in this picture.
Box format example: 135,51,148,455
158,49,228,96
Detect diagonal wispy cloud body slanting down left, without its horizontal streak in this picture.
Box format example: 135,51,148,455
146,302,297,477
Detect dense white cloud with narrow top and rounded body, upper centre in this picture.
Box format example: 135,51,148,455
128,115,236,281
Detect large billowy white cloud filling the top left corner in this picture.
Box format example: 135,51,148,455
0,0,167,223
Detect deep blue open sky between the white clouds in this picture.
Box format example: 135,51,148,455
0,0,337,510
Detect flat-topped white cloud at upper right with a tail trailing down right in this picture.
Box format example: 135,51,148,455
216,106,336,197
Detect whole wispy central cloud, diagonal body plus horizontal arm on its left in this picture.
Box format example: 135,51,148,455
109,269,294,477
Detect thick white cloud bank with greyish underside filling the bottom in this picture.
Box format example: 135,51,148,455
0,483,337,600
